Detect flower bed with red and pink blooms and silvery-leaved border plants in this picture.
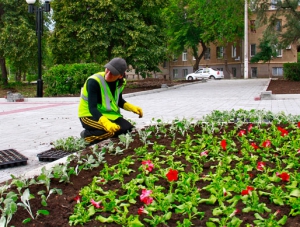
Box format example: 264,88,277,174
0,110,300,227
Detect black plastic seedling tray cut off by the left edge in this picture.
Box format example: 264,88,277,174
0,149,28,169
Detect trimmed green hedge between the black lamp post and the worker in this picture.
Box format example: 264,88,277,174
43,63,104,96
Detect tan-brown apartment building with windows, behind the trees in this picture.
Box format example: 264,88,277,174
154,0,297,79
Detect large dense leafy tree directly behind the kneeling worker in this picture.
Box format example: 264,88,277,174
50,0,168,77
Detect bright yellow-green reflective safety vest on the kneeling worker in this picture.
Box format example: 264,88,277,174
78,72,126,120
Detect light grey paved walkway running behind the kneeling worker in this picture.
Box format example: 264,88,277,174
0,79,300,182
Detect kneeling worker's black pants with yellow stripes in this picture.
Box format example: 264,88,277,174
79,117,133,143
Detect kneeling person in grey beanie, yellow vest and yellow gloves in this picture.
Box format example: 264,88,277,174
78,58,143,144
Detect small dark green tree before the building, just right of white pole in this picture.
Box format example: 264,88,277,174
250,35,278,77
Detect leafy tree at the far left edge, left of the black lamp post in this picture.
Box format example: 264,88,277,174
0,0,37,84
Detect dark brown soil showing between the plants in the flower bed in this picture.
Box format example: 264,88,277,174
4,124,300,227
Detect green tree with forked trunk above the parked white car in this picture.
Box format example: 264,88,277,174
164,0,244,71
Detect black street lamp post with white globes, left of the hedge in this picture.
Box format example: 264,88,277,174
26,0,50,97
